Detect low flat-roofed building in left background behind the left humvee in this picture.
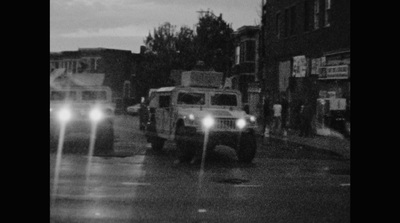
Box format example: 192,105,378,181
50,48,141,112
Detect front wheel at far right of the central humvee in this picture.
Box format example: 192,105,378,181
237,133,257,163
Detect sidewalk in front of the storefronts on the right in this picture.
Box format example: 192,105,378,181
263,127,350,159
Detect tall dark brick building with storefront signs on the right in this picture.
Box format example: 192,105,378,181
260,0,350,130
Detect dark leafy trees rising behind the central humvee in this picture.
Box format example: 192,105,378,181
138,12,233,95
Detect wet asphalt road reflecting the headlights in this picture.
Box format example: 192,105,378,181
50,116,350,222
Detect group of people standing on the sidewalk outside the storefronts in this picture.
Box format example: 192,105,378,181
263,95,313,137
